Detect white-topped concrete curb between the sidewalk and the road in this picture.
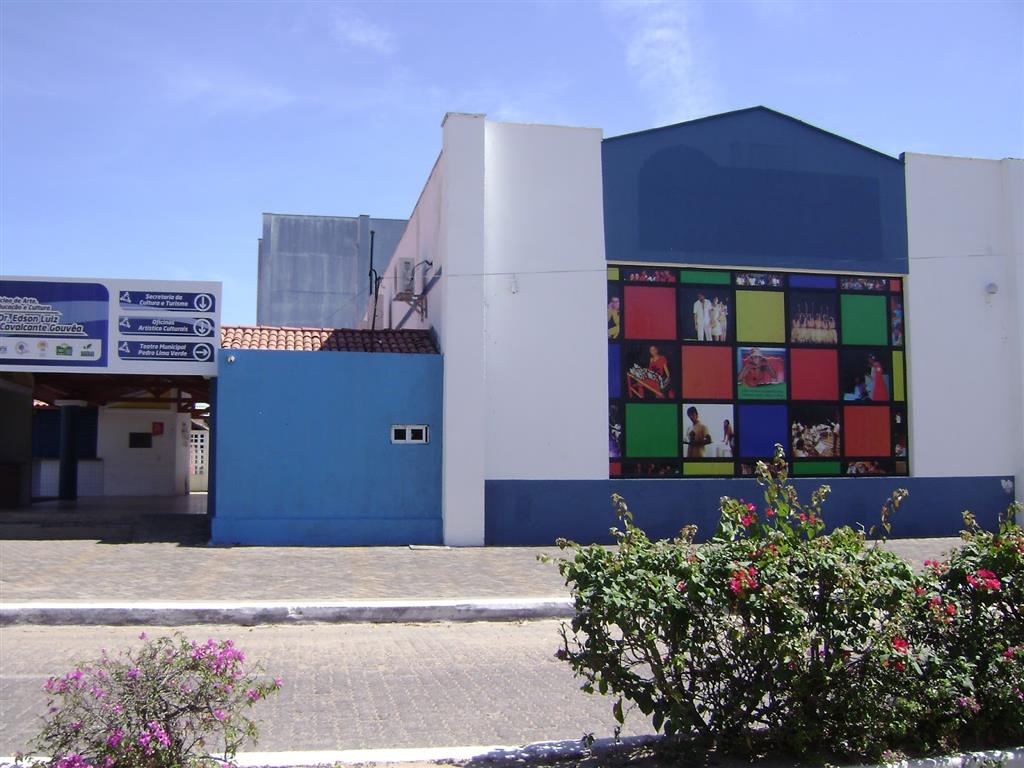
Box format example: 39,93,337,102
0,597,573,627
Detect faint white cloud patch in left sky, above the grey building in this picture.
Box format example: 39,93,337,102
164,69,295,113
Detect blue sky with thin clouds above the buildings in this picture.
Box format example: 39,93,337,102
0,0,1024,324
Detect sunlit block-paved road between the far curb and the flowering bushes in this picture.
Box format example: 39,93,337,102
0,621,651,755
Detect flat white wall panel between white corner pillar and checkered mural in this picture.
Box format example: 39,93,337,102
484,122,608,479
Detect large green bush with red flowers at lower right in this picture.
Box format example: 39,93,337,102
558,451,1024,759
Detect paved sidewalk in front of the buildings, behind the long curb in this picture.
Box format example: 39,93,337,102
0,539,958,603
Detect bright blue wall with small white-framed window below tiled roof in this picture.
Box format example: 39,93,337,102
212,349,442,546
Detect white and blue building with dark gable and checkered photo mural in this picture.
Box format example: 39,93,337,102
366,108,1024,545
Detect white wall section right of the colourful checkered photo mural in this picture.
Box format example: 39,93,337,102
905,154,1024,499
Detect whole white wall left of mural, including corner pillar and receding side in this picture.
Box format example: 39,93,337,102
383,114,608,546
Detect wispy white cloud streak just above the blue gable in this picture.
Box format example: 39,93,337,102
605,0,711,123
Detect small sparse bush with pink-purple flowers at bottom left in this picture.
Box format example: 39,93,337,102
19,633,281,768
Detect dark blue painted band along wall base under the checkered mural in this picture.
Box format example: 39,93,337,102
484,477,1013,546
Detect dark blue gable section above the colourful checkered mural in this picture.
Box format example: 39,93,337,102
601,106,907,274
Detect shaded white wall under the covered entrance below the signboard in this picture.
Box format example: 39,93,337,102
96,407,189,496
